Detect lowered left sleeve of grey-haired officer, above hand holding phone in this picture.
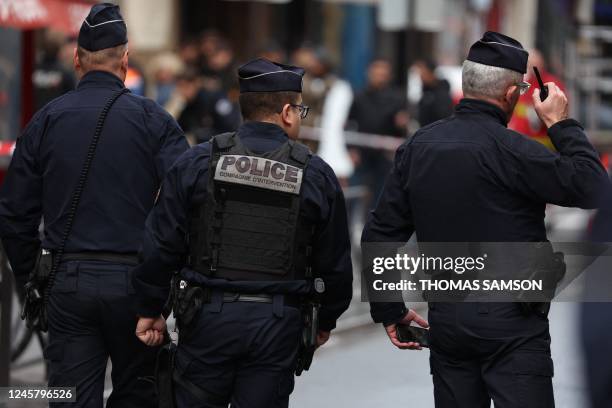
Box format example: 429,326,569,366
361,144,414,326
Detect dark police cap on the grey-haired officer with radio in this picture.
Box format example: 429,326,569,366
467,31,529,74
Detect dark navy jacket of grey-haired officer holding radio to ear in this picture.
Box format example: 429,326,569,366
361,99,609,323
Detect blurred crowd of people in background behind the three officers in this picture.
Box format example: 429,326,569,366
32,25,468,212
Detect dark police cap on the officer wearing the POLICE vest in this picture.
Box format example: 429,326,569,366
238,58,304,93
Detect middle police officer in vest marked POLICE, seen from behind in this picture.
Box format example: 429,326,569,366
134,59,352,408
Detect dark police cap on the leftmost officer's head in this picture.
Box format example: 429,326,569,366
78,3,127,51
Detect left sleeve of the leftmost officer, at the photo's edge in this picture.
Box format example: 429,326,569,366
0,111,45,285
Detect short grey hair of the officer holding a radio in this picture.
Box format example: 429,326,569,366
461,60,523,99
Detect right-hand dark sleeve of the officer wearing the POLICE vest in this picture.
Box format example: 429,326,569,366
313,163,353,331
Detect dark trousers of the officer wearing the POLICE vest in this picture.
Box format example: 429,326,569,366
175,299,302,408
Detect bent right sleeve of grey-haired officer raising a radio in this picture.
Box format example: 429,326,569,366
512,119,609,208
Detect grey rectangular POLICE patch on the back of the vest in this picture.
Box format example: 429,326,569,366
215,155,304,194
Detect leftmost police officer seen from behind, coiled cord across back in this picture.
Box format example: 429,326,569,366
0,4,189,407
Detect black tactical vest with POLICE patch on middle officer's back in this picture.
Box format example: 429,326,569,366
189,133,314,281
